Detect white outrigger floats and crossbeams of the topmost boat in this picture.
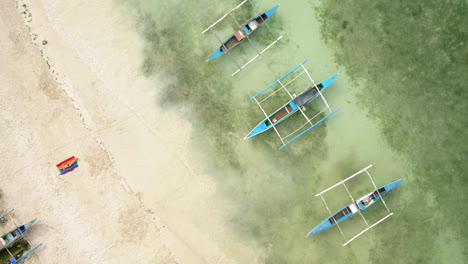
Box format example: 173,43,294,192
202,0,283,76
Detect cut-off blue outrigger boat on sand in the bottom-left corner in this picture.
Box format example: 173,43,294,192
0,209,42,264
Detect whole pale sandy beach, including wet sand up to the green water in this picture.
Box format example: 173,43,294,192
0,1,255,263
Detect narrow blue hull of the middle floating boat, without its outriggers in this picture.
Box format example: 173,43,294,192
244,74,338,139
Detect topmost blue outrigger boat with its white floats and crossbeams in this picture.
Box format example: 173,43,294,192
202,0,283,76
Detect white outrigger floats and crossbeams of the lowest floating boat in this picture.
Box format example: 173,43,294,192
315,164,393,246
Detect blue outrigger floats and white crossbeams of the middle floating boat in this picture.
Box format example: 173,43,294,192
250,60,340,150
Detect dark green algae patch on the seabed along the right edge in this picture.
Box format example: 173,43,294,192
316,0,468,263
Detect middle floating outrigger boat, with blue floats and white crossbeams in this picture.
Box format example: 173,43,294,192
244,60,339,149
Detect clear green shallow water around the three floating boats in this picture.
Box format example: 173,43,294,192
120,0,467,263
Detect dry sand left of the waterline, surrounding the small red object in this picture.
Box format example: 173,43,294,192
0,2,177,263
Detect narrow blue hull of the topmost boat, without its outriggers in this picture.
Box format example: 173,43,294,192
208,5,279,60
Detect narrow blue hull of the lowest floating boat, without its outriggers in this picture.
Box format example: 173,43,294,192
307,179,404,236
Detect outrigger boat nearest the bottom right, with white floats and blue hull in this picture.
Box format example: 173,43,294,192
307,165,404,246
